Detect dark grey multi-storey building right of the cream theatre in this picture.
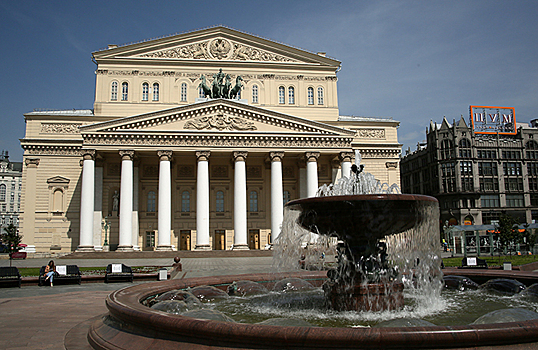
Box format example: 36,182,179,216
400,113,538,225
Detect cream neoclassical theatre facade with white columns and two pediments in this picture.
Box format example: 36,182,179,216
21,26,401,252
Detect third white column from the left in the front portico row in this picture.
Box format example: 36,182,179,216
156,151,172,251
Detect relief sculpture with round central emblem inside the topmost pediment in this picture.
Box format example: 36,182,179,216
140,38,297,62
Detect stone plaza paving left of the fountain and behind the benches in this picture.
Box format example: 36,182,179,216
0,256,272,350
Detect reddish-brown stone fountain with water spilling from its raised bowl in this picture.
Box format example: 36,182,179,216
88,152,538,349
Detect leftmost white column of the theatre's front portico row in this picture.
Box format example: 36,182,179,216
77,149,95,251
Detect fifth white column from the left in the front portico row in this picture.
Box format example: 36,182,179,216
233,152,248,250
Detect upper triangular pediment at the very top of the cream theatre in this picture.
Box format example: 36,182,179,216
93,26,340,67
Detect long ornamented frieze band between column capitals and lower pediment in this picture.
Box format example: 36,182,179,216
84,135,352,149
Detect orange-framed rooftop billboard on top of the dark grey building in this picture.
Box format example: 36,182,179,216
469,106,517,135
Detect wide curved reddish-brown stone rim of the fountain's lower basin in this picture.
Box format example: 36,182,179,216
88,270,538,350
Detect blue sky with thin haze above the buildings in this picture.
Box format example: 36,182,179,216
0,0,538,161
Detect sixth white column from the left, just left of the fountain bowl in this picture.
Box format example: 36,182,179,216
269,152,284,244
